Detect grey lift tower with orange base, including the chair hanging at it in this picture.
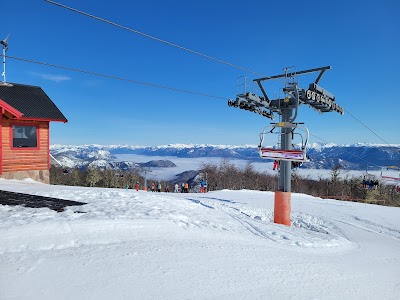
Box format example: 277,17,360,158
228,66,344,226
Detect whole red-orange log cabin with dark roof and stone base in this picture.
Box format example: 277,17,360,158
0,83,68,183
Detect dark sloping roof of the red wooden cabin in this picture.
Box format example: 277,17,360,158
0,83,68,122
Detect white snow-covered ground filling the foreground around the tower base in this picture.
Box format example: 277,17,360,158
0,179,400,300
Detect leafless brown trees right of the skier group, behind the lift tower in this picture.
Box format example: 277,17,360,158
202,159,400,206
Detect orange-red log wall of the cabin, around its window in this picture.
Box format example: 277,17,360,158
2,118,49,173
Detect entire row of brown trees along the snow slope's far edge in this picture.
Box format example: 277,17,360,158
50,159,400,206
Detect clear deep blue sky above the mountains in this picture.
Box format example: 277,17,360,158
0,0,400,146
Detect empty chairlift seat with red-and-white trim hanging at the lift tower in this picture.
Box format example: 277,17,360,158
258,122,310,162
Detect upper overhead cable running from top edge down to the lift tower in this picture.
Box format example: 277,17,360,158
44,0,264,76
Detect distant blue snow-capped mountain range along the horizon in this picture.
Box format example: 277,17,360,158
50,143,400,170
